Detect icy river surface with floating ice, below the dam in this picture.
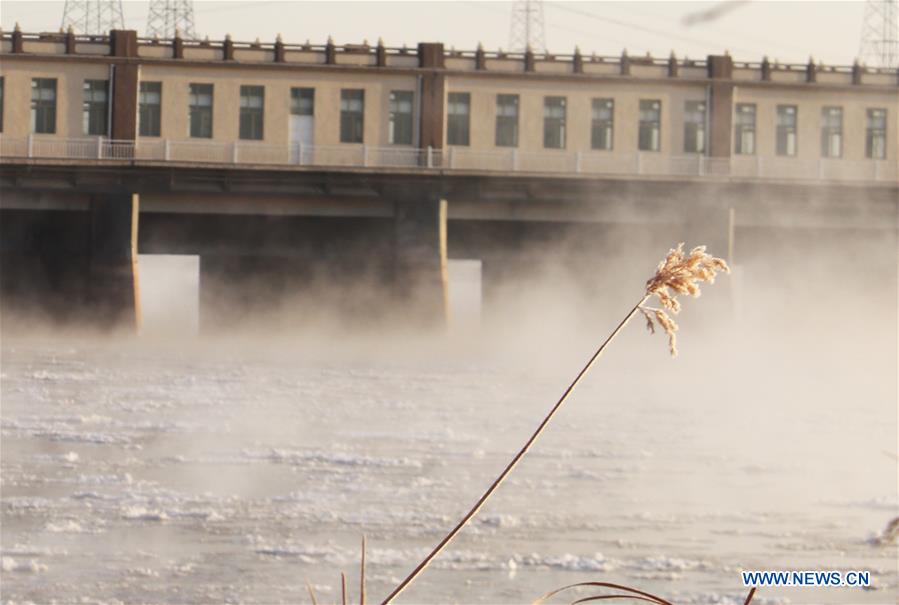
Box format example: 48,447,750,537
0,329,899,604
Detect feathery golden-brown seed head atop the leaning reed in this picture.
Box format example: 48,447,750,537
640,242,730,357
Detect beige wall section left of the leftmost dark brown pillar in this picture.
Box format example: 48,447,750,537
0,61,109,138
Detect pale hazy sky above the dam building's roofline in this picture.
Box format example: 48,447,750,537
0,0,884,65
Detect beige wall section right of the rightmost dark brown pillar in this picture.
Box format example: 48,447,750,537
734,86,899,162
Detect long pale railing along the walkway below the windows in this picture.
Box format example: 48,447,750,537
0,135,899,182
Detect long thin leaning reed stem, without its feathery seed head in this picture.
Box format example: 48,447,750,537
382,294,651,605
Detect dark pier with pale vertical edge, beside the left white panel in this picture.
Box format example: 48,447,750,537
88,194,140,330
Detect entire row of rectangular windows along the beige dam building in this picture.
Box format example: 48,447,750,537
0,78,887,159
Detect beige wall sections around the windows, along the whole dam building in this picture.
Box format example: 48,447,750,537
0,57,899,173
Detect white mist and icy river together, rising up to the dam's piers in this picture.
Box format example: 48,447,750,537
0,205,899,604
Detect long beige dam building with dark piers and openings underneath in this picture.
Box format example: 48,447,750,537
0,28,899,325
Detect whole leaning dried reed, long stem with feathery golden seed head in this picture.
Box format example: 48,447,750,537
382,243,730,605
